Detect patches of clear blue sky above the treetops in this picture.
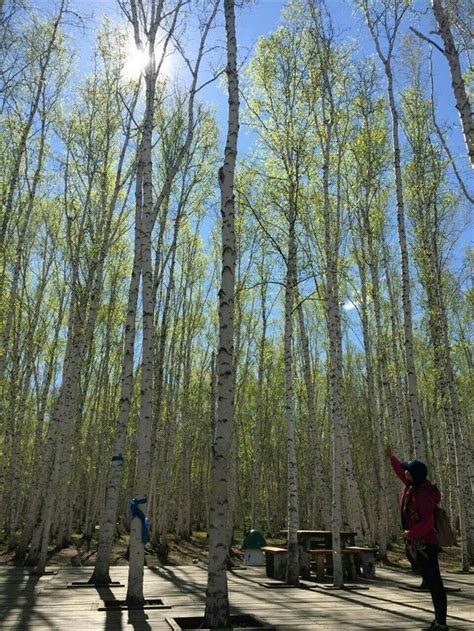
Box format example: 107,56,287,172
32,0,474,258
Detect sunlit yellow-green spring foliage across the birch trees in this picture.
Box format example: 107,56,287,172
0,0,474,548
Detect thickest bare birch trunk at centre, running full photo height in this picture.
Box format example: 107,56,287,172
204,0,239,629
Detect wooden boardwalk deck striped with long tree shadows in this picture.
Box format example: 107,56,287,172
0,565,474,631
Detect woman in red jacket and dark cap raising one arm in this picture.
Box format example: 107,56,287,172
386,446,448,631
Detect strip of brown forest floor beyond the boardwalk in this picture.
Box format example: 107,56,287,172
0,532,461,570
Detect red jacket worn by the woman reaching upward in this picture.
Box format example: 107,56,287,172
390,456,441,543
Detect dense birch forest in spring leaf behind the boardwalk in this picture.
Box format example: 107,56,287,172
0,0,474,626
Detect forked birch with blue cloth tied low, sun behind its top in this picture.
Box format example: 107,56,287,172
122,0,217,604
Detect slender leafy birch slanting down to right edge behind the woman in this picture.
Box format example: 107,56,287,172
403,63,472,569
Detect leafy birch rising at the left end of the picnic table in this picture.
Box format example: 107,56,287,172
244,7,308,584
